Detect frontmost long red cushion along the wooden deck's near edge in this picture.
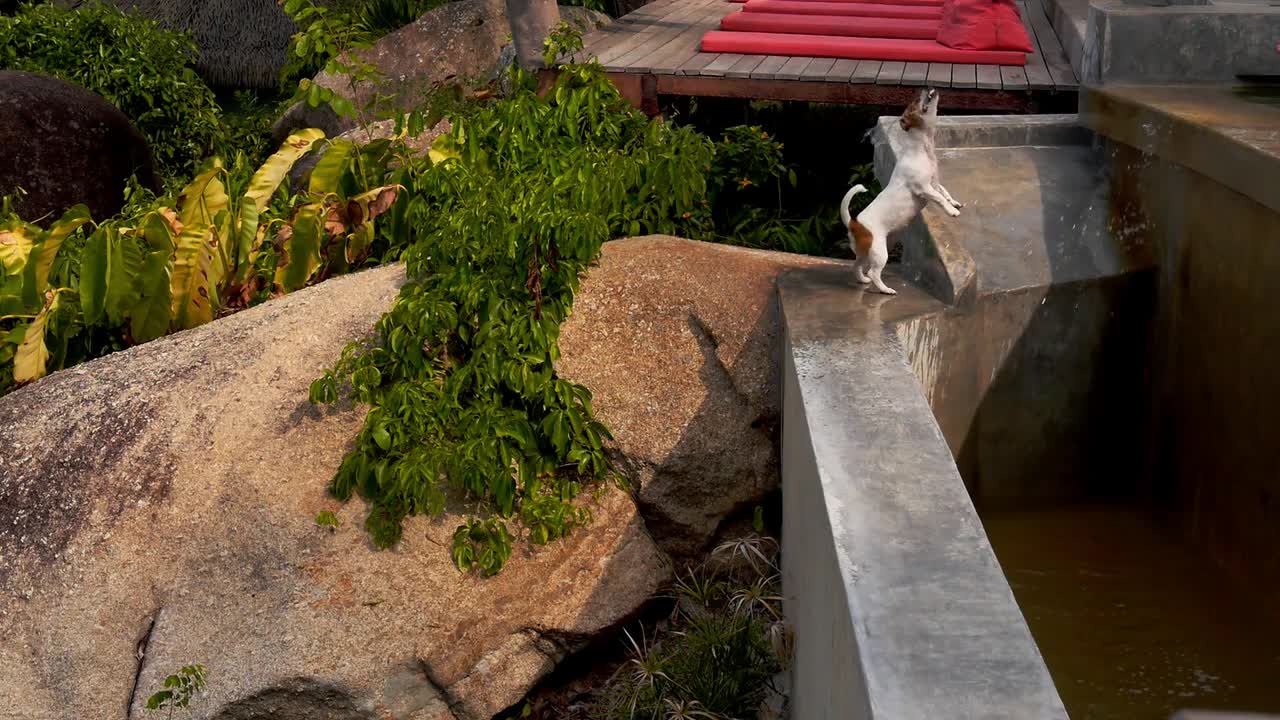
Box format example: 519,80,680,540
703,29,1027,65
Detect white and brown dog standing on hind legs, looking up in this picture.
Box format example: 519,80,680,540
840,87,964,295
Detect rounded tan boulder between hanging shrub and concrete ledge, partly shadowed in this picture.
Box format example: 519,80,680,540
557,237,840,561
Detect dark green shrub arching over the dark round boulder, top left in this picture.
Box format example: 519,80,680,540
0,3,224,176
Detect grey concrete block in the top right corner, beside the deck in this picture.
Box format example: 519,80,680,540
1078,0,1280,86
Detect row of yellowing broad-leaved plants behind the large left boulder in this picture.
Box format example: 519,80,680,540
0,129,399,392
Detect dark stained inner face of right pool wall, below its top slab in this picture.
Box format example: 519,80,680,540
1100,145,1280,600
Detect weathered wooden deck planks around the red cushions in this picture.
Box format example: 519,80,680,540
582,0,1078,114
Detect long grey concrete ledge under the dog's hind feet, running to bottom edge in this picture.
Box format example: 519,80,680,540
778,270,1066,720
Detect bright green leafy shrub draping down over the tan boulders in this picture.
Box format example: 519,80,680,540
311,28,714,573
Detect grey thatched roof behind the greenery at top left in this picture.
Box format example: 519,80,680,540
73,0,297,87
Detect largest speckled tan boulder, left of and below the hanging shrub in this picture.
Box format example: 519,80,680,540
0,268,669,720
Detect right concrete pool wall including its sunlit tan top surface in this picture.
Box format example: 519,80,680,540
1082,88,1280,601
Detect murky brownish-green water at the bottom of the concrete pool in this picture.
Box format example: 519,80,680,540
982,507,1280,720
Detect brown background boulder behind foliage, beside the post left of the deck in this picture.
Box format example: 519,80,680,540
273,0,609,141
